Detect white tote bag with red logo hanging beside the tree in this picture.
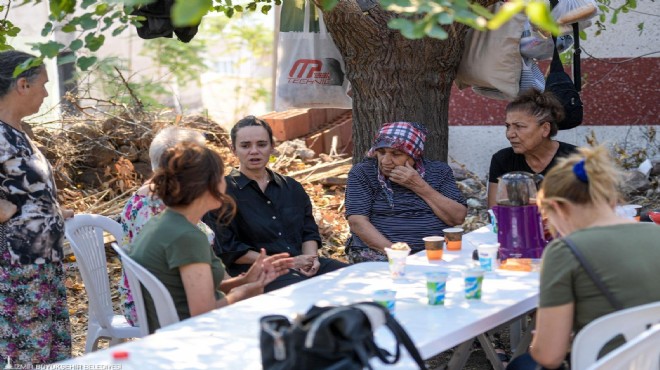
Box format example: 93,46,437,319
275,0,352,111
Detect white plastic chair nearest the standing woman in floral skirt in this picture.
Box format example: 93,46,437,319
64,214,141,353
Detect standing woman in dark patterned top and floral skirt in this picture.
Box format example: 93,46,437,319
0,50,73,366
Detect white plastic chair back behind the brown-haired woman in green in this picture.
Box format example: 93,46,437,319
112,243,180,336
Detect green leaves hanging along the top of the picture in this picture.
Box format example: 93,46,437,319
0,0,644,73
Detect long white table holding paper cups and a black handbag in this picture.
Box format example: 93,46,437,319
59,228,539,369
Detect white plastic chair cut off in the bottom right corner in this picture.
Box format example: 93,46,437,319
588,324,660,370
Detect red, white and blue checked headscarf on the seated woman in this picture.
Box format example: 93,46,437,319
367,122,428,207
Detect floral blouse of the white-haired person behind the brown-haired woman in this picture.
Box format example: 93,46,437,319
118,191,215,326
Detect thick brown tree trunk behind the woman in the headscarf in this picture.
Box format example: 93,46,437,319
323,0,490,162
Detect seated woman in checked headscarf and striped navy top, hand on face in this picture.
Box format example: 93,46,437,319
346,122,467,263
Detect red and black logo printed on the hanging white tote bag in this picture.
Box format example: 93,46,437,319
288,58,344,86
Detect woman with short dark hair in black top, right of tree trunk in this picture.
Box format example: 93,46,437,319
488,90,576,208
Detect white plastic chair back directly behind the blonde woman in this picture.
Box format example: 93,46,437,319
571,302,660,369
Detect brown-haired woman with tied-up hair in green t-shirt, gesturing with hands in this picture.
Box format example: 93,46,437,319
129,143,292,333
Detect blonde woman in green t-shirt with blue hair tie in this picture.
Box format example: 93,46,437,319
508,147,660,369
